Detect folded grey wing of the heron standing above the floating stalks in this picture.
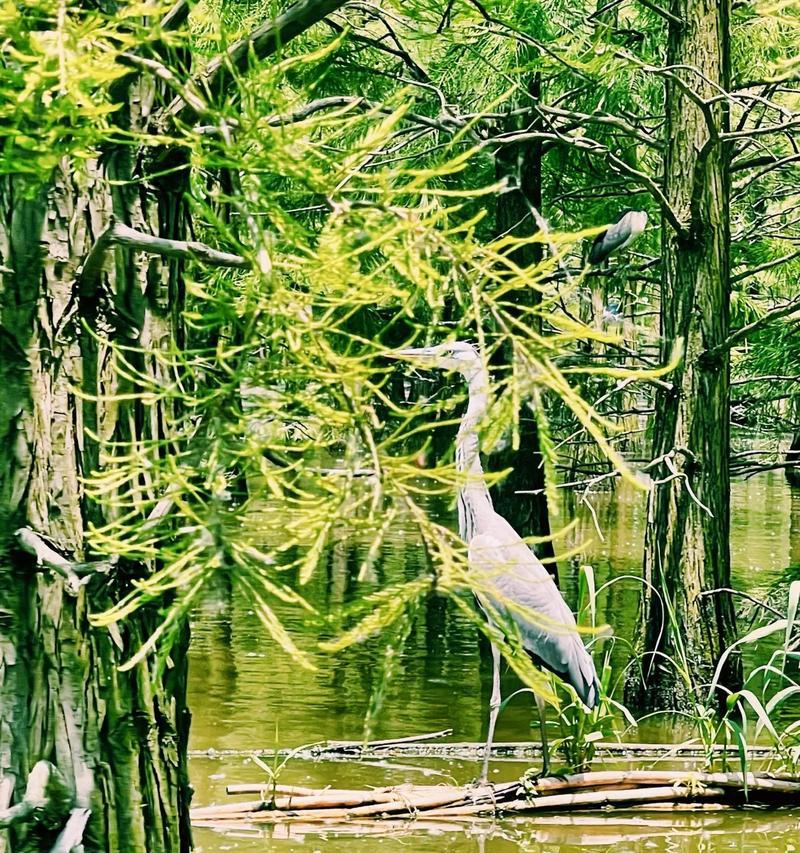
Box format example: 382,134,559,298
469,532,598,708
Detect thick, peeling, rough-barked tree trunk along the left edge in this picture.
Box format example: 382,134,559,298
0,88,191,853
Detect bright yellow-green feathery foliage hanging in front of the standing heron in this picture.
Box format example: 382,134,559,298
2,0,664,717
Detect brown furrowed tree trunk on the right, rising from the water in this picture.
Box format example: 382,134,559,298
628,0,740,709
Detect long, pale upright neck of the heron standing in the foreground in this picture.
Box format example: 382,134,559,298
456,366,492,543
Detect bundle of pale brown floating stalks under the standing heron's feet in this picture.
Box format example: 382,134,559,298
192,770,800,829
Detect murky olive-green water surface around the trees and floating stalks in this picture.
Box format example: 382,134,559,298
189,473,800,853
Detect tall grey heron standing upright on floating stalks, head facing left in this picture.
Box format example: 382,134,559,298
393,341,600,782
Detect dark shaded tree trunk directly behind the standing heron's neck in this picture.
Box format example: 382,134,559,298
489,74,558,583
